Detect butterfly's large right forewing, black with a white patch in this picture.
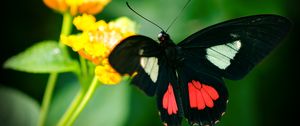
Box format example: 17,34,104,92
178,15,291,79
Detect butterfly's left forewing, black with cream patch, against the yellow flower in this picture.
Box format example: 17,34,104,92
109,35,161,96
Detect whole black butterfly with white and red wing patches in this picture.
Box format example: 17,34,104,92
109,15,291,126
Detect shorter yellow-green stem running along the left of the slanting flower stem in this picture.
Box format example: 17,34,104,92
57,90,85,126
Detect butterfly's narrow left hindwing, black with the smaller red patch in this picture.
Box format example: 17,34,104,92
156,59,183,126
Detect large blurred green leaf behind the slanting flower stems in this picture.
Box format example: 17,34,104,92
46,82,130,126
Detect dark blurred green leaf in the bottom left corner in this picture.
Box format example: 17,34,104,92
0,85,39,126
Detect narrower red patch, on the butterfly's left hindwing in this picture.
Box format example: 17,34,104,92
162,83,178,115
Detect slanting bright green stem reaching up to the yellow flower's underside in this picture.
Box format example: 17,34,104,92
66,76,98,126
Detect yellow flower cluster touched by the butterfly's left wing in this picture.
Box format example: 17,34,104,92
61,14,135,84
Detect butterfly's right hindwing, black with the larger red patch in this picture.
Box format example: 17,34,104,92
177,58,228,126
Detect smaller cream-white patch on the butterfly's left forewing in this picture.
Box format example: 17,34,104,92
140,57,159,82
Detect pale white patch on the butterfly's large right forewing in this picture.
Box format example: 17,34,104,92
206,40,242,69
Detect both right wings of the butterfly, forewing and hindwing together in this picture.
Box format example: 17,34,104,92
177,15,290,125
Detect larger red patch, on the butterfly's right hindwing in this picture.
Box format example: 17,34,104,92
188,80,219,110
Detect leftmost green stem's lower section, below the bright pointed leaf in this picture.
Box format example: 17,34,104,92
38,73,57,126
